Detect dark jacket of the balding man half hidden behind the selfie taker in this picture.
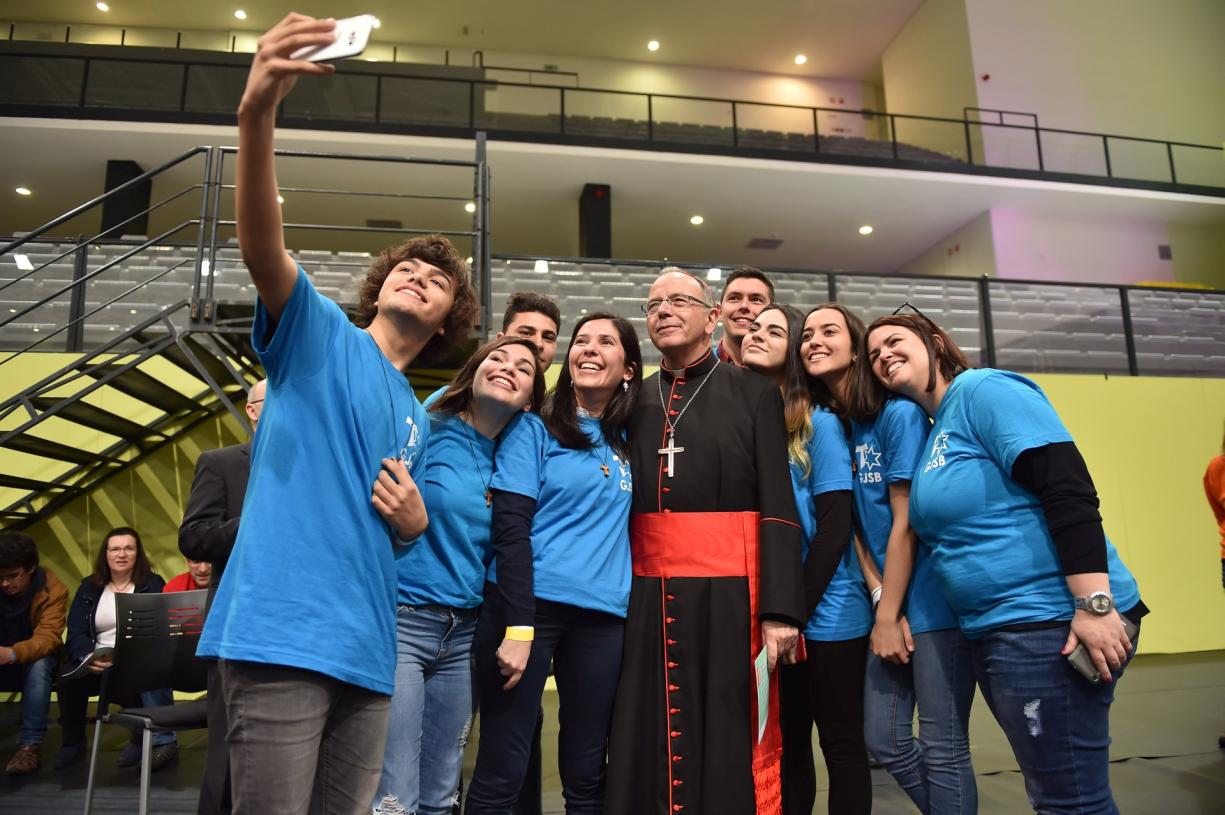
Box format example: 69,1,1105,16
179,442,251,586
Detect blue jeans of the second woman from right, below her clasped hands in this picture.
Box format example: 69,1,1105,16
864,629,979,815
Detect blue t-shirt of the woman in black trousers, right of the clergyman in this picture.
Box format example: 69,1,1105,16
791,408,872,642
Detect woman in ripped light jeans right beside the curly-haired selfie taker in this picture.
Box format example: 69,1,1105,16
374,337,544,813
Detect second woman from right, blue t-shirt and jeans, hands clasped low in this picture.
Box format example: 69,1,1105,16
804,303,978,815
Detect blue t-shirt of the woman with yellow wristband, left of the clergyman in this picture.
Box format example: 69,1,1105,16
490,413,633,616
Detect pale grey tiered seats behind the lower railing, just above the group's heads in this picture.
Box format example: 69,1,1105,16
0,236,1225,376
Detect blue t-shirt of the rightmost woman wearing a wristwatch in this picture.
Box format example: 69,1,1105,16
910,368,1139,639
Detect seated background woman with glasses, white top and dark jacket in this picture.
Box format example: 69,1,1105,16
55,527,179,770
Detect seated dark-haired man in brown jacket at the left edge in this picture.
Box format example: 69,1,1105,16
0,532,69,776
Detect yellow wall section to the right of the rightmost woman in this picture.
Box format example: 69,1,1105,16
1034,374,1225,653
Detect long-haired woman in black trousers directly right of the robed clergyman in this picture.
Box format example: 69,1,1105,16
742,305,872,815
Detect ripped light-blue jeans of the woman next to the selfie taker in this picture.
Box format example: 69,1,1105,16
374,605,478,815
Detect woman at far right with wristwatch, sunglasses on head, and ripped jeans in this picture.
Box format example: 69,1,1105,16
867,314,1148,813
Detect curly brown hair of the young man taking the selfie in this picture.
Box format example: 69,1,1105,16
354,234,480,363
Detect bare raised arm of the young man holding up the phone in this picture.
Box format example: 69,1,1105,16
234,13,336,322
